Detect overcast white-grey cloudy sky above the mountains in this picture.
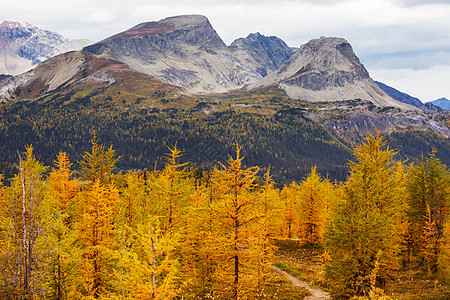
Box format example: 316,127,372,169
0,0,450,101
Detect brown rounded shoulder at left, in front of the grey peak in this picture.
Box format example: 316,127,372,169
0,51,183,102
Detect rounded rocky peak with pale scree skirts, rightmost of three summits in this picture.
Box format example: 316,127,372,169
249,37,413,109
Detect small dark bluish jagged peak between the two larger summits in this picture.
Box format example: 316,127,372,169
230,32,294,77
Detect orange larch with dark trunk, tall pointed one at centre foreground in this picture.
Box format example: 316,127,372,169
209,146,262,299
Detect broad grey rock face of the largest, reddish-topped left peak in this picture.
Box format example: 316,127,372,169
84,15,261,93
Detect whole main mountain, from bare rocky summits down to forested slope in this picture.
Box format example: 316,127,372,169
0,16,450,182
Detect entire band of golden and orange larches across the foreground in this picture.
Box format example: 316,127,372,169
0,135,450,299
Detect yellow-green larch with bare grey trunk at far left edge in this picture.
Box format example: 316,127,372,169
0,146,46,299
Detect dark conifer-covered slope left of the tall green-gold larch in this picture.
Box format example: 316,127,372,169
0,95,351,181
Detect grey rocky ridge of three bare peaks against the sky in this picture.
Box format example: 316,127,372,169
0,15,426,109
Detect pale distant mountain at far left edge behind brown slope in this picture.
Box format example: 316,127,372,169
0,21,92,75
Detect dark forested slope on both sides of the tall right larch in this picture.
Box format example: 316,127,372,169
0,92,450,183
